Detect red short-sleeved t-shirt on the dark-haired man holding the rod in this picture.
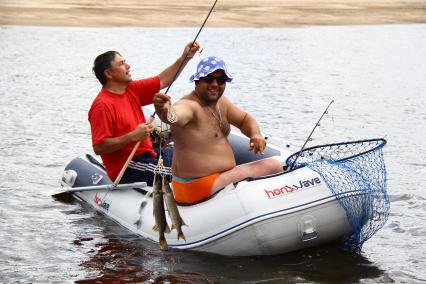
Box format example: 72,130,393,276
89,76,160,181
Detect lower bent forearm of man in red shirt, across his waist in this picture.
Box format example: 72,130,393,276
93,122,153,155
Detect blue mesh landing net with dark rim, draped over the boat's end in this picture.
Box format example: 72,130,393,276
286,139,390,252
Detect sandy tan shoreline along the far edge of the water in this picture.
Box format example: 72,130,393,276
0,0,426,27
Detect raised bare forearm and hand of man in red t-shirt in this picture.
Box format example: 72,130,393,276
158,42,200,89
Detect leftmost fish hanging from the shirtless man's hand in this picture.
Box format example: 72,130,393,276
152,175,170,250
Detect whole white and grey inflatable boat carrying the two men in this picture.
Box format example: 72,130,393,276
57,129,389,256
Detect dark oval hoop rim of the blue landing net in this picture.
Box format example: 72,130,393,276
286,138,387,168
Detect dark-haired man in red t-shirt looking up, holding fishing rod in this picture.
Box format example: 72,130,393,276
89,42,200,184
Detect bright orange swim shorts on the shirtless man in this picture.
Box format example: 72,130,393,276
172,173,220,204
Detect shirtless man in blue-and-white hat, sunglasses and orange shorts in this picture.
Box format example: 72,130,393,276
154,56,283,203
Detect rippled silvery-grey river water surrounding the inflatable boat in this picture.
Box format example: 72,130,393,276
0,25,426,283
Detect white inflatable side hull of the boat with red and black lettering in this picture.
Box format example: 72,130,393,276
65,154,356,256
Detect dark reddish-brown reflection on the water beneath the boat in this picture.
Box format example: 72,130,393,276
74,206,390,283
